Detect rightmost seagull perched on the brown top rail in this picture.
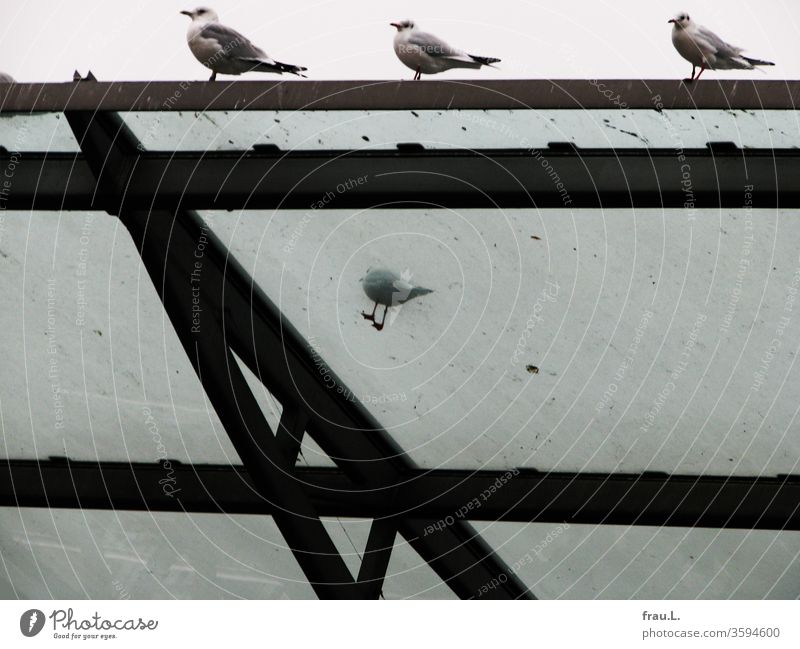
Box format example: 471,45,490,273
667,12,775,83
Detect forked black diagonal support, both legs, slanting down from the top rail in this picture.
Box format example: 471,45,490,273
59,112,530,599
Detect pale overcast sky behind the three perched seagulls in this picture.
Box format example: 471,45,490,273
0,0,800,81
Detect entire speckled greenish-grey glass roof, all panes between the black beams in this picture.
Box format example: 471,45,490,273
0,92,800,599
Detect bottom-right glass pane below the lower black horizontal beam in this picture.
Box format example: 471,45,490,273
475,523,800,599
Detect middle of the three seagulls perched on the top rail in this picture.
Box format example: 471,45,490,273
389,20,500,81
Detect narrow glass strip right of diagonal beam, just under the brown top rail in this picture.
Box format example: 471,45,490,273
124,109,800,151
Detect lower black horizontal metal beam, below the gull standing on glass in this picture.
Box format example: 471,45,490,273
6,460,800,528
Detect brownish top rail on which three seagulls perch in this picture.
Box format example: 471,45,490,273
0,79,800,113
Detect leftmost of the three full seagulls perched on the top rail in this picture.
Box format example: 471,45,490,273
181,7,306,81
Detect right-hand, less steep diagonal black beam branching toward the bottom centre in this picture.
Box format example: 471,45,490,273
186,176,533,599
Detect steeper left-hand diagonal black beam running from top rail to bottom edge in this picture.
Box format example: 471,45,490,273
66,112,362,599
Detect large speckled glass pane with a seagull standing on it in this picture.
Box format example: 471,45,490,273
206,205,800,475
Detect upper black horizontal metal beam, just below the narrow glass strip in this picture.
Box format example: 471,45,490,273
0,145,800,210
